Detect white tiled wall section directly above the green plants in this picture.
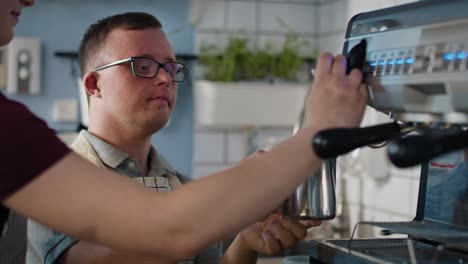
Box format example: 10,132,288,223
194,0,318,55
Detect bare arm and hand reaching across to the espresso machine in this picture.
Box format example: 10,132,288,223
4,54,366,259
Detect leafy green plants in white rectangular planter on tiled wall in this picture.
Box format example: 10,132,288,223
194,34,316,127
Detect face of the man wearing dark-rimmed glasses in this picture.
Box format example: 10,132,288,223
90,29,177,135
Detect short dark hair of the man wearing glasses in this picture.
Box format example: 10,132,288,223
78,12,162,77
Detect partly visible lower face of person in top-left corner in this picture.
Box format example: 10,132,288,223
0,0,34,47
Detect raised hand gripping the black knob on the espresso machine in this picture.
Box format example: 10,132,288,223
303,53,367,130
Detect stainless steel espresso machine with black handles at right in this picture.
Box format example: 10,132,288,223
302,0,468,263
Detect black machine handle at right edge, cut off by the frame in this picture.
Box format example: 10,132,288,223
387,129,468,168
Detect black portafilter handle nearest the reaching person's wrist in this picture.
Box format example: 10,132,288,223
312,122,402,159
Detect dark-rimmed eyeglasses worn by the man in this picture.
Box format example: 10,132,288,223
93,57,188,82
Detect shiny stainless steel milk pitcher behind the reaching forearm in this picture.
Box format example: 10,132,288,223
281,110,336,220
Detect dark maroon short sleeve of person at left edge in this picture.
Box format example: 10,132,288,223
0,93,70,200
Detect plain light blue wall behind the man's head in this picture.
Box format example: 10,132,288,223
9,0,194,175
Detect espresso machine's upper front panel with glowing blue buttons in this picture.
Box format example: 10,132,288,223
345,16,468,124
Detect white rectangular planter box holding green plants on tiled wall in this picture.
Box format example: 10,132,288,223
194,81,309,128
